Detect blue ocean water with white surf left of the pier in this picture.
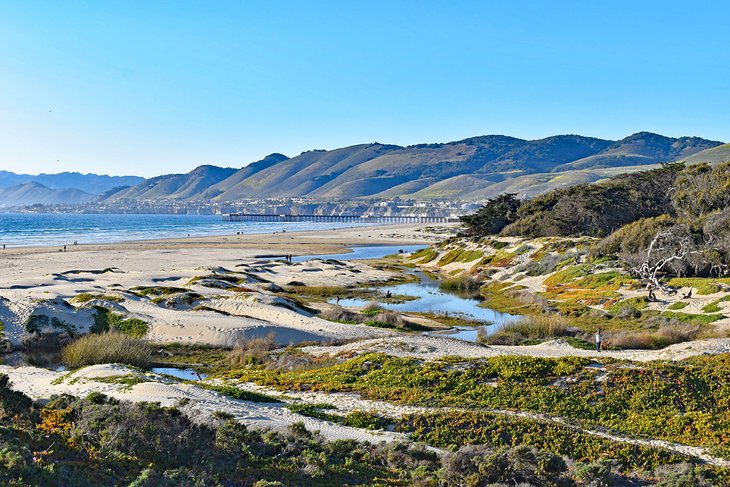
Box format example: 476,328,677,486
0,213,376,248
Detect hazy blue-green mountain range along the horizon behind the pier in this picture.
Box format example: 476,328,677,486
0,132,730,207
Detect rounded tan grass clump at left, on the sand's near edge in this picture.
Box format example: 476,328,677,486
61,332,153,369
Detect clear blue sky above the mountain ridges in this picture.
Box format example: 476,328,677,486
0,0,730,176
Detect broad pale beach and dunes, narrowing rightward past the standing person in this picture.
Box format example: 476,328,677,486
0,219,730,360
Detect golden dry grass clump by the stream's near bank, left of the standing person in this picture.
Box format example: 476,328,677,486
477,313,569,345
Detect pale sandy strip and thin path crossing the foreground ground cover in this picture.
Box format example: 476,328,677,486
0,364,730,467
